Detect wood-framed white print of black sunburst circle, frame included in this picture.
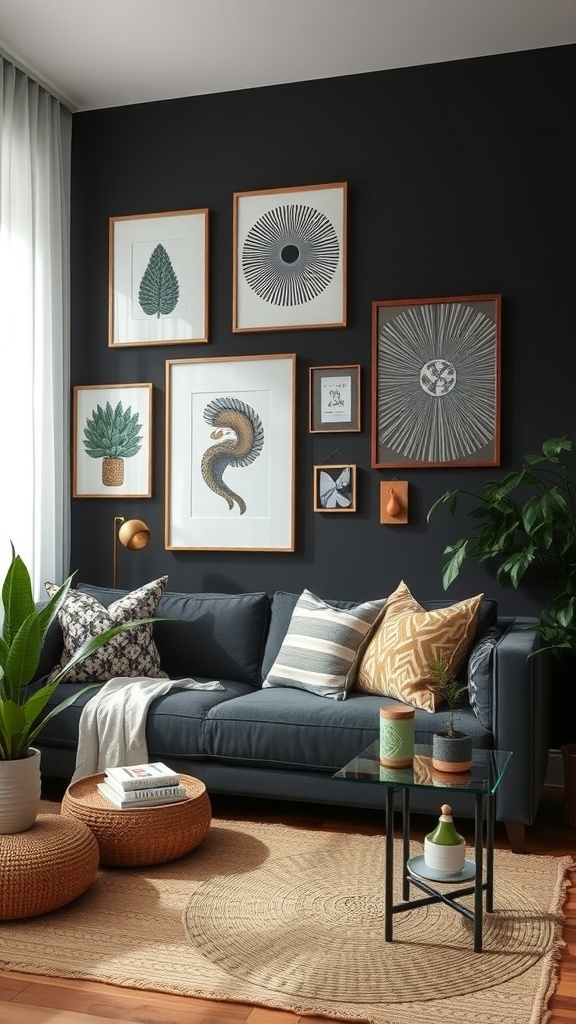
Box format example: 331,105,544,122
232,181,347,333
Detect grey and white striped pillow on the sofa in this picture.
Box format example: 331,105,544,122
262,590,386,700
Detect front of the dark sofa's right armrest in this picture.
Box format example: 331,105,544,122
492,617,552,824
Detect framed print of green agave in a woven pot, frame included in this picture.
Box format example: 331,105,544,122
72,384,153,498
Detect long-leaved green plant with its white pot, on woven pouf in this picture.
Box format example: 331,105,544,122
0,546,151,835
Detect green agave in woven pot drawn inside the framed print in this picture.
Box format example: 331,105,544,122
84,401,142,487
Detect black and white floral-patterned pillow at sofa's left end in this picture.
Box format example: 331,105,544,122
45,577,168,683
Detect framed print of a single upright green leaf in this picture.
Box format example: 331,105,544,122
109,210,208,348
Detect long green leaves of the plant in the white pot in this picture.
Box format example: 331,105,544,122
0,545,152,761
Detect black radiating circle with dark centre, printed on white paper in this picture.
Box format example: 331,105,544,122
242,203,340,307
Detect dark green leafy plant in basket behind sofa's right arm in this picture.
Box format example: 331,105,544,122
428,436,576,827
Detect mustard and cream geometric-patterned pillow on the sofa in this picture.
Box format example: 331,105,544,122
356,582,484,714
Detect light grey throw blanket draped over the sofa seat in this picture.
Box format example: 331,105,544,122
72,676,224,782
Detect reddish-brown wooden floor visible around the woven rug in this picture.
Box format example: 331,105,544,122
0,787,576,1024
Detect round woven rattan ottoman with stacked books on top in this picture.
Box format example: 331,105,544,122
61,774,212,867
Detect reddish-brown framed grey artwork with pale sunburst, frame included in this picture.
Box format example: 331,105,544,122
372,295,501,469
